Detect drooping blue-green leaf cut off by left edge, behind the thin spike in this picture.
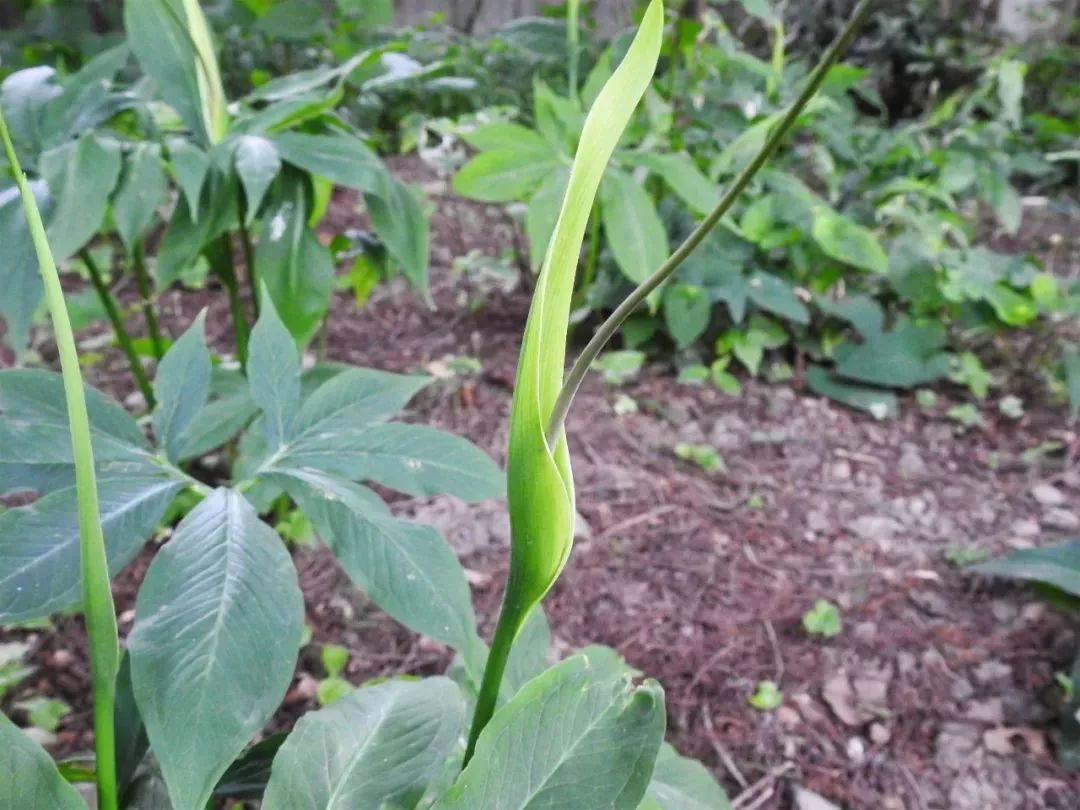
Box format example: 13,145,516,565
0,180,53,356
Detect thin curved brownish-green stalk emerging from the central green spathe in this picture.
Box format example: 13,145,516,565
546,0,874,446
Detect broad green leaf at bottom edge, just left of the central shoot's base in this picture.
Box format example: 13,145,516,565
262,677,464,810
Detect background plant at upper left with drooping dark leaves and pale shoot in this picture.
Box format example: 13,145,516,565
0,0,428,397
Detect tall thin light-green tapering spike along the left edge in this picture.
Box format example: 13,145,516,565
0,111,120,810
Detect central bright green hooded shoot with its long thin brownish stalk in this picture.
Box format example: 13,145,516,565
464,0,873,765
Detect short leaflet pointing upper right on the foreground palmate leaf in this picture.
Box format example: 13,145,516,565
296,368,431,432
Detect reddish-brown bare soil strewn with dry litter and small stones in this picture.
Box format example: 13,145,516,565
0,155,1080,810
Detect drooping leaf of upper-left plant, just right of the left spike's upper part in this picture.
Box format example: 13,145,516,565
41,134,121,260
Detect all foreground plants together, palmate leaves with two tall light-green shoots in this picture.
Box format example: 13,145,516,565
0,0,885,810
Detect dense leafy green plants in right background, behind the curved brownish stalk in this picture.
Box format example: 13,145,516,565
454,3,1080,416
